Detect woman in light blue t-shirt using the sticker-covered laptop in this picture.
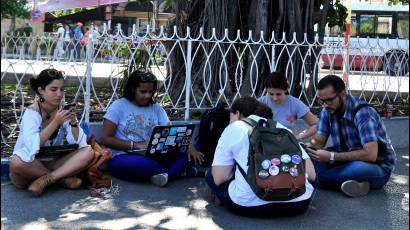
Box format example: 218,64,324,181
101,70,203,187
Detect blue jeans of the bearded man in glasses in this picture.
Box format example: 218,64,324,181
312,160,391,190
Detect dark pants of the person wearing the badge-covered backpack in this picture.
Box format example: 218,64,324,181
205,169,311,217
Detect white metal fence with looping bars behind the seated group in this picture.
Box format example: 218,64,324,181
1,26,409,146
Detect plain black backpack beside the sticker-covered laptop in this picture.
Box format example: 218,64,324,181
198,104,229,167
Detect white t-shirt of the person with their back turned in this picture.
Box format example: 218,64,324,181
212,115,313,207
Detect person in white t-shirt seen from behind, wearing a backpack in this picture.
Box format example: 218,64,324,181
205,97,316,217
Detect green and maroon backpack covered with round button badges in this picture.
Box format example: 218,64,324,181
235,118,306,201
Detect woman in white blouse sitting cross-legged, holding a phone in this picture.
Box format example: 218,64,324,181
10,69,94,196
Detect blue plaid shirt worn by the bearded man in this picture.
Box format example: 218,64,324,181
317,95,396,172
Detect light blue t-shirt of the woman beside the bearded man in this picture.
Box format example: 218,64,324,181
258,95,310,129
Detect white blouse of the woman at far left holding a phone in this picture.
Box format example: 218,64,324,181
13,108,88,163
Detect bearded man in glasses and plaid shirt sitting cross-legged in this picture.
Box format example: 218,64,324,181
307,75,396,197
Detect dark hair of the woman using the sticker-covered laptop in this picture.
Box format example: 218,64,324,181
122,70,158,104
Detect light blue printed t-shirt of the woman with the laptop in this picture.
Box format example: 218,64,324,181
104,98,169,156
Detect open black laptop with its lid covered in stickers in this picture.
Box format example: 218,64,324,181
127,124,195,164
